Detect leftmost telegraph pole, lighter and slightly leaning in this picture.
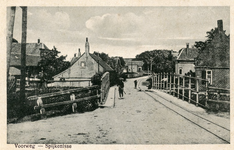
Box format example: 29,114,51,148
6,7,15,89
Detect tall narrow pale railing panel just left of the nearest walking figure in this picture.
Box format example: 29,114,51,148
99,72,110,104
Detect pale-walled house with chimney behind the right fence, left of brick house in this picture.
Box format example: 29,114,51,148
175,43,198,75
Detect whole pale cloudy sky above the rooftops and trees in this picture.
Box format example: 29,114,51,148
9,6,230,61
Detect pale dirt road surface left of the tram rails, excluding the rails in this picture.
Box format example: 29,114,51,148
7,79,229,144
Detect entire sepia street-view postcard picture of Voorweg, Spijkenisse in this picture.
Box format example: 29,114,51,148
2,0,231,149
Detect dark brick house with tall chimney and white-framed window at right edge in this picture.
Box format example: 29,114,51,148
195,20,230,89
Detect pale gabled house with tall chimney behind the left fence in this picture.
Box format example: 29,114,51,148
53,38,114,86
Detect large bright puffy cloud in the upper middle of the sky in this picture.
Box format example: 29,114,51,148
85,12,144,38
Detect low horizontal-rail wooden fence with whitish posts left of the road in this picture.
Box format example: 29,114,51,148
27,86,99,114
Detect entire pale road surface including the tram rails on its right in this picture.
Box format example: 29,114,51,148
7,77,230,144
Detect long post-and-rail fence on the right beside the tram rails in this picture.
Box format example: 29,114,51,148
152,73,230,109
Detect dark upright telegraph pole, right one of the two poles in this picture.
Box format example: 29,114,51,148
20,7,27,104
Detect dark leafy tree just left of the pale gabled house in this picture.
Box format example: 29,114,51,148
38,47,70,79
